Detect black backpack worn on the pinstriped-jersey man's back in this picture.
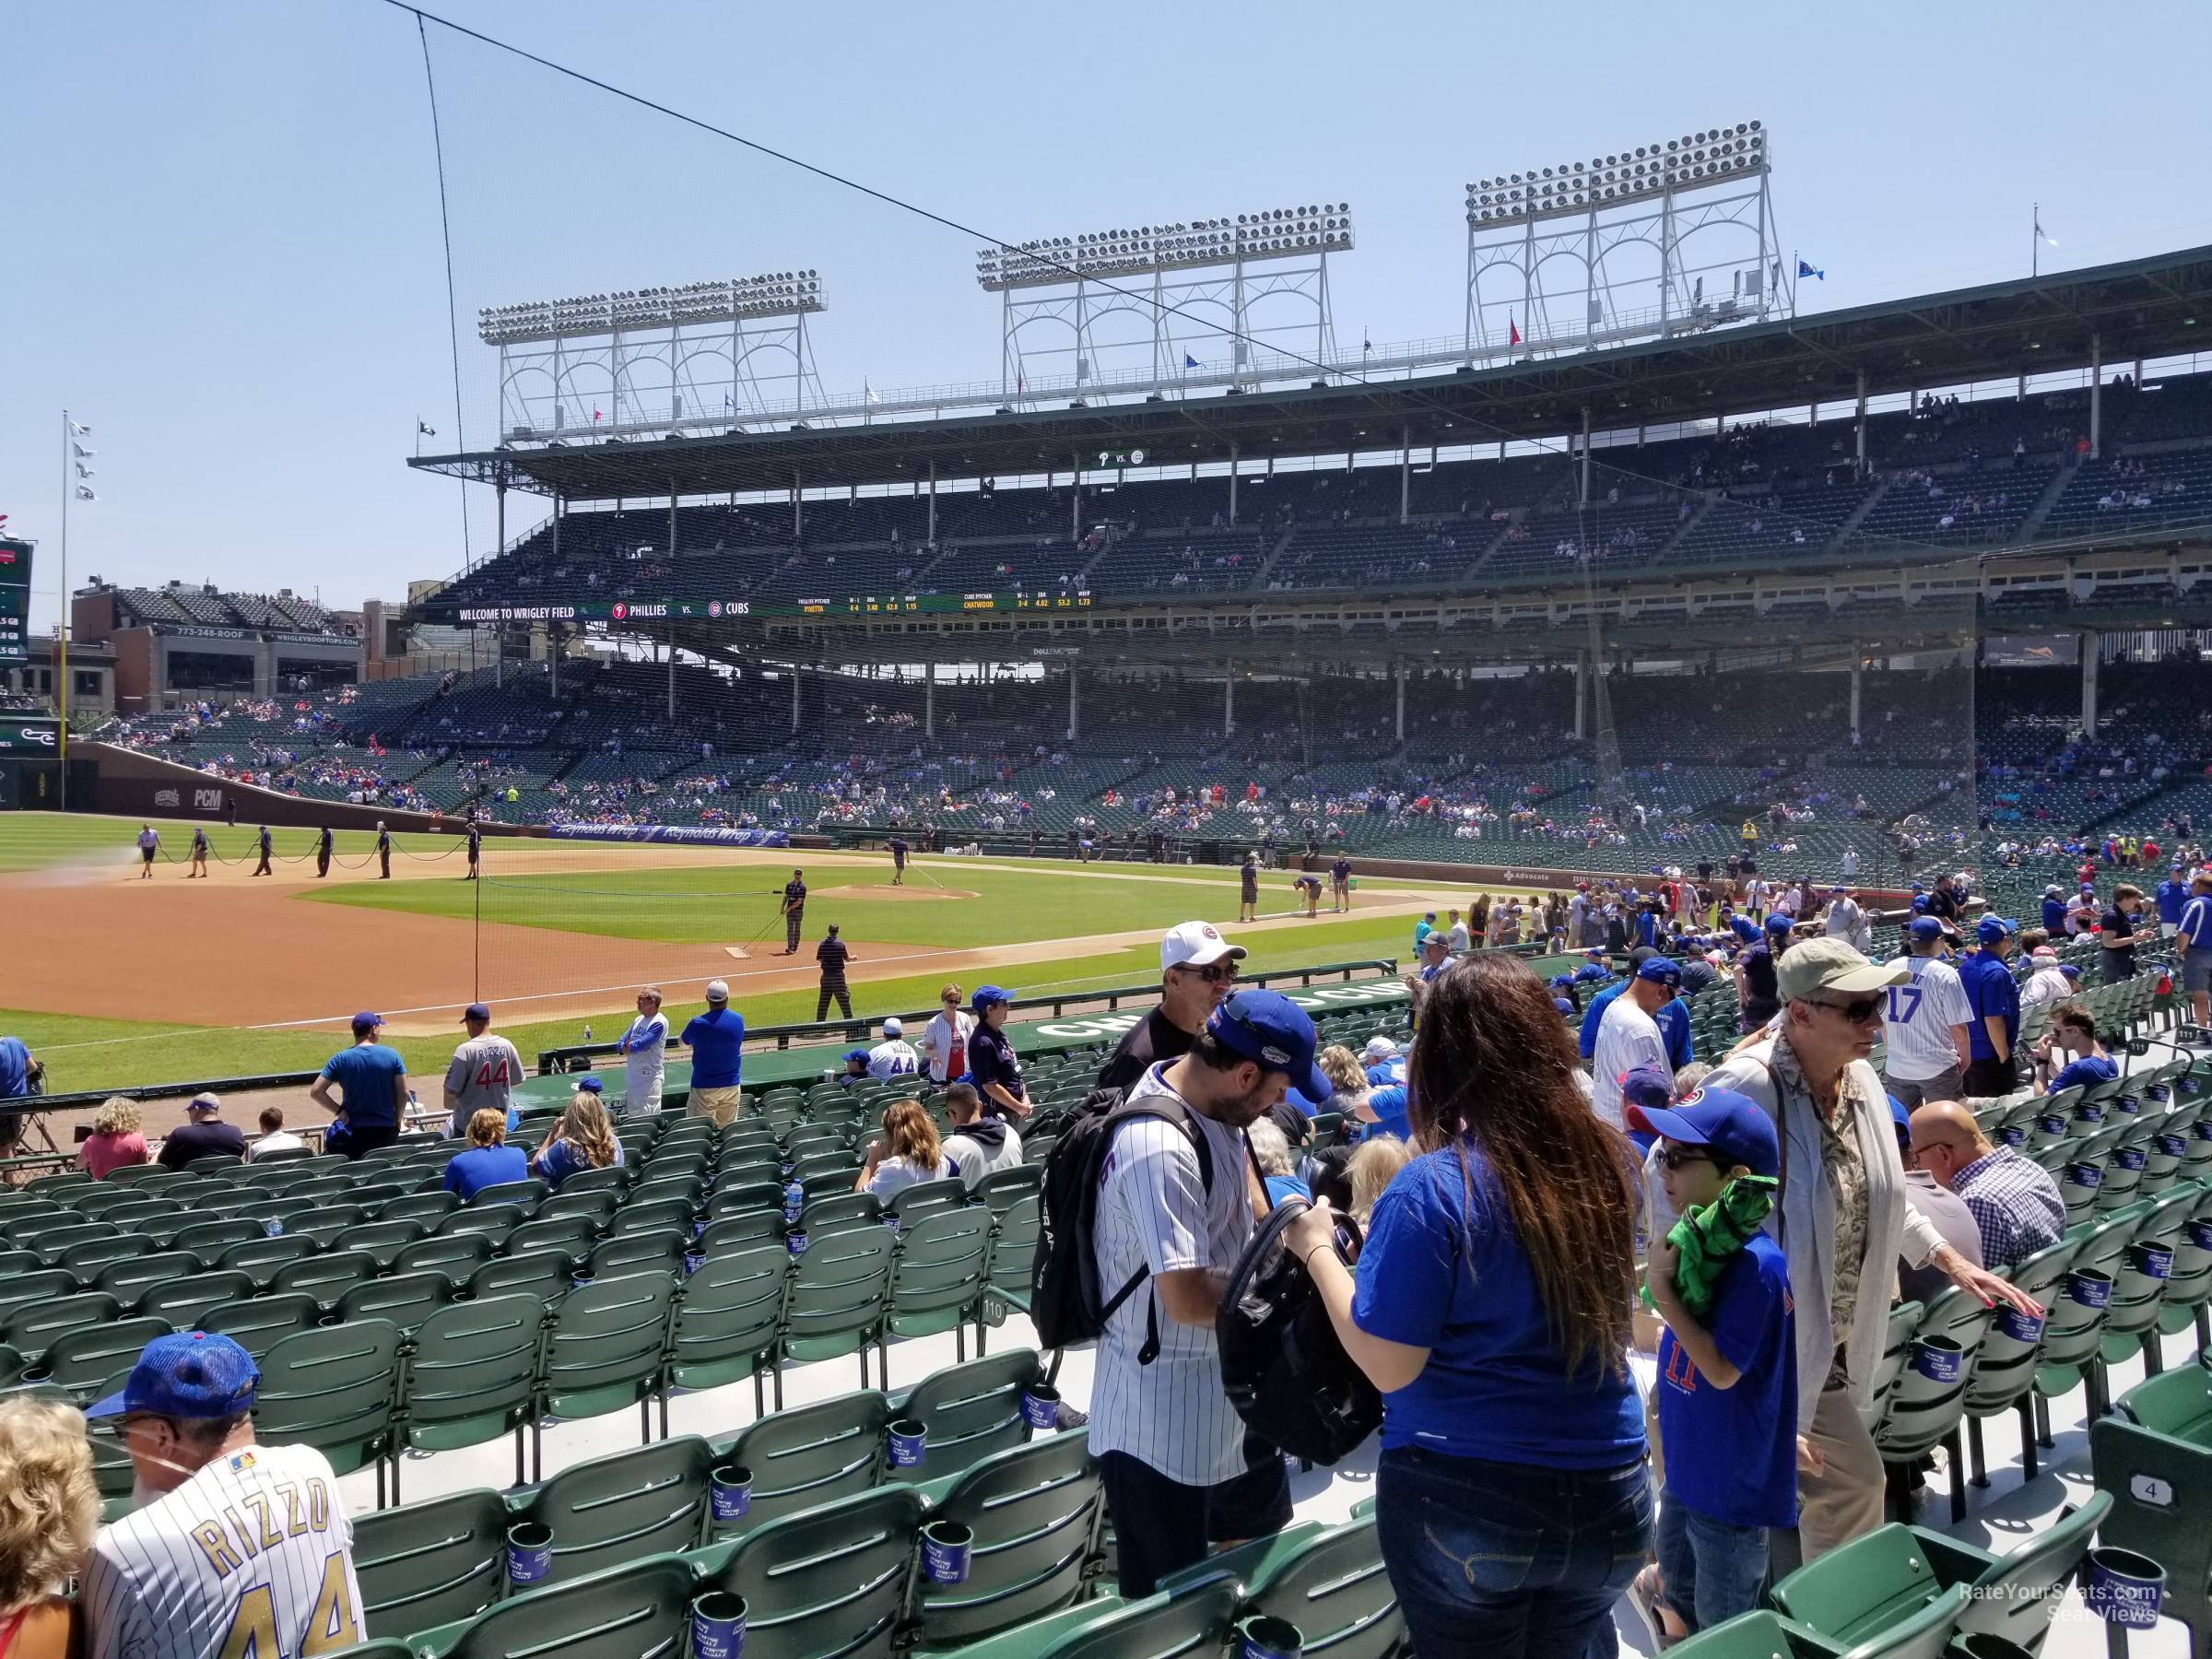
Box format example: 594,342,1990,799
1029,1088,1215,1365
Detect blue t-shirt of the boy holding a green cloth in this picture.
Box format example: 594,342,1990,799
1659,1232,1798,1526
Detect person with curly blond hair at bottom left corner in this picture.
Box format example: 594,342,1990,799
0,1398,100,1659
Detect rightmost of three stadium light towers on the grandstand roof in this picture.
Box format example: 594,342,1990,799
1466,122,1794,360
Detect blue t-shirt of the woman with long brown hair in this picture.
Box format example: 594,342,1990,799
1351,1144,1643,1469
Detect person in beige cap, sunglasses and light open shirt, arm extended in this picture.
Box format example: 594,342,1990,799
1689,938,2041,1559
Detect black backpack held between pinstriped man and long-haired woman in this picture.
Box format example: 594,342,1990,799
1215,1199,1382,1465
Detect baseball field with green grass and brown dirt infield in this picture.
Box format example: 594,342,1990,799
0,812,1548,1093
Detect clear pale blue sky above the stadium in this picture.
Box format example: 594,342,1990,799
0,0,2212,626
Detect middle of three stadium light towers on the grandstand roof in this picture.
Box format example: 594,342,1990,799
975,201,1351,398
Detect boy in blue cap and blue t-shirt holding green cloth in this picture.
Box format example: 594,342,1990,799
1630,1088,1798,1639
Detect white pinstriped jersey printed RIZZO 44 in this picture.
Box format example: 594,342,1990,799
82,1447,363,1659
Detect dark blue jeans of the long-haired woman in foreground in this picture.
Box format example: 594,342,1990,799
1376,1447,1653,1659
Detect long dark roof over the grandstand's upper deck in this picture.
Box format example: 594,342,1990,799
409,245,2212,502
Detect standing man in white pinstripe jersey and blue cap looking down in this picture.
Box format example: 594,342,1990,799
1090,991,1329,1597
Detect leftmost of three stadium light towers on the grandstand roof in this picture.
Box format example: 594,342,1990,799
476,270,823,442
